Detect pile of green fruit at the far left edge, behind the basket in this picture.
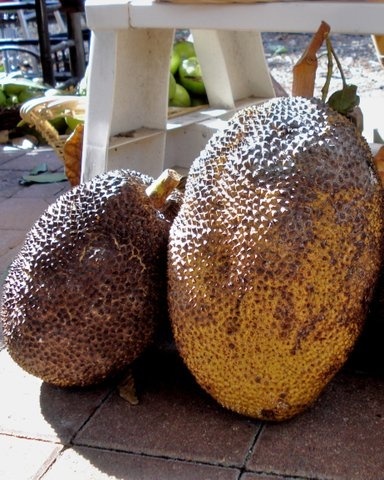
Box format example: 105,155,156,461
0,77,46,108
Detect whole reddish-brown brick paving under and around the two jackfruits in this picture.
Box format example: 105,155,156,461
0,143,384,480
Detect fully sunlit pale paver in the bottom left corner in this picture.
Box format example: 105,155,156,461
0,435,62,480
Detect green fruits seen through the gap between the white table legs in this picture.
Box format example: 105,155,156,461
168,40,208,107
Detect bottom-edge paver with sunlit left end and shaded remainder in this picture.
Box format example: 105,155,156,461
41,447,239,480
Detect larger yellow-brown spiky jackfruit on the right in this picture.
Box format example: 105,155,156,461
168,97,384,421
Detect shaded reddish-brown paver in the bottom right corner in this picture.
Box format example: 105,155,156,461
247,374,384,480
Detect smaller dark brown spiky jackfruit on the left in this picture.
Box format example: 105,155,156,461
1,170,170,386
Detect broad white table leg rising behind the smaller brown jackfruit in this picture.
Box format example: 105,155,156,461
82,29,174,180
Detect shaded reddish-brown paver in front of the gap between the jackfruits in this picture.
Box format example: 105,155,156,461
73,354,260,466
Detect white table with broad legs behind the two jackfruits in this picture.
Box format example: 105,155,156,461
82,0,384,180
